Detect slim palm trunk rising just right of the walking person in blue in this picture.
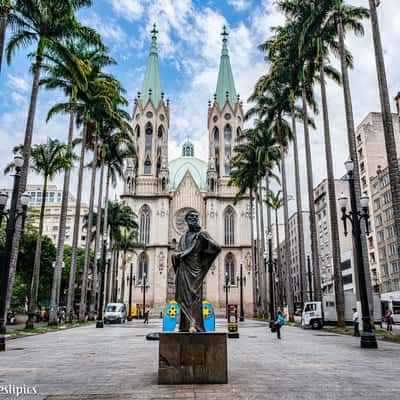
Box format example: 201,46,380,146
280,143,294,321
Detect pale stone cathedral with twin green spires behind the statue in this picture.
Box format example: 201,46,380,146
118,26,253,314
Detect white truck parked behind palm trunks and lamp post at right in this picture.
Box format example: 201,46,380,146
301,292,382,329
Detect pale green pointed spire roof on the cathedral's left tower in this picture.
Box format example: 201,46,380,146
142,24,162,107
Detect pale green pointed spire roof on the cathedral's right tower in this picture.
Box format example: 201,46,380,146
216,26,237,108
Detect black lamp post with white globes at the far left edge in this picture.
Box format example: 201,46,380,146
0,155,29,351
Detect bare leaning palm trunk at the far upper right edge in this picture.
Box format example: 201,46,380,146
369,0,400,262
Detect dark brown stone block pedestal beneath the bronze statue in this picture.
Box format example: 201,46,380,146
158,332,228,385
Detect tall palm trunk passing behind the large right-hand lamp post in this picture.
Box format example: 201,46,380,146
336,15,373,315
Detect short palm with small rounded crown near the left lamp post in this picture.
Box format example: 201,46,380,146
7,138,75,328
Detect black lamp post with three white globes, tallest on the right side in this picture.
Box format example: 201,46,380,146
338,160,378,349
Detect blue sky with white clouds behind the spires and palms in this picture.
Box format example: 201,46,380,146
0,0,400,219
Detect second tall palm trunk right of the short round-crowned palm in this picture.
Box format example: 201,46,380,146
67,123,87,322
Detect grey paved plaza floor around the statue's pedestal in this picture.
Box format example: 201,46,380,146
0,320,400,400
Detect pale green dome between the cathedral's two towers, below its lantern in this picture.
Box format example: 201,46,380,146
169,157,207,190
